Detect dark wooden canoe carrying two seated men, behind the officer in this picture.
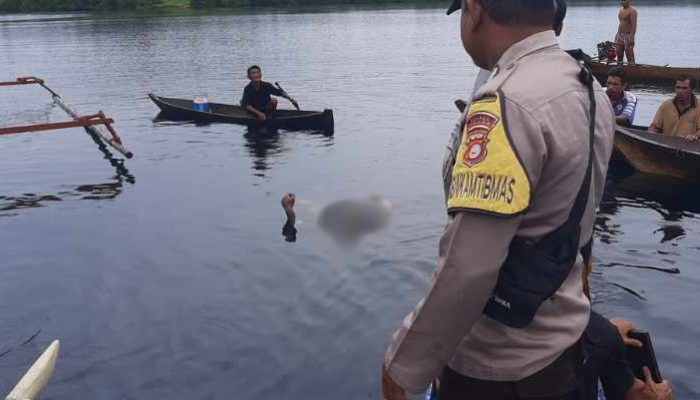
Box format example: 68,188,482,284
615,125,700,182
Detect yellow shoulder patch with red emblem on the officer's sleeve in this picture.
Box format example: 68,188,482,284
447,96,531,216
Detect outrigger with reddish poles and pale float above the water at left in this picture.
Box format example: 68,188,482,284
0,76,134,158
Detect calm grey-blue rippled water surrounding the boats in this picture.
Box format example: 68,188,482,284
0,5,700,399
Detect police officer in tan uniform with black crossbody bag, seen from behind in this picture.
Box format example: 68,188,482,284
382,0,615,400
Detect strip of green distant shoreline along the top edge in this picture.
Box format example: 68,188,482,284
0,0,445,14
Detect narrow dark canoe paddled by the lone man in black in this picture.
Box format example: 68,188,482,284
148,93,334,135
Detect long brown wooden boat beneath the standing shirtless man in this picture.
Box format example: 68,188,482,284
591,61,700,88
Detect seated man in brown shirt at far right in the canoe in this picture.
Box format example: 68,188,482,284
649,75,700,140
